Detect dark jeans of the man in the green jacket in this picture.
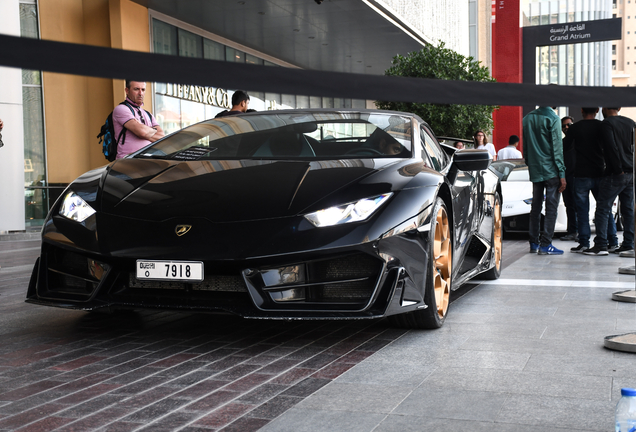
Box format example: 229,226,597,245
528,177,561,247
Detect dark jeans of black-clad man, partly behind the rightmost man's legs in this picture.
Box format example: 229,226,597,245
574,177,618,247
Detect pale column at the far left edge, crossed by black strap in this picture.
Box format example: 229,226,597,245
0,0,25,233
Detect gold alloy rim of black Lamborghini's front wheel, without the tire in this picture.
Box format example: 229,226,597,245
433,207,453,318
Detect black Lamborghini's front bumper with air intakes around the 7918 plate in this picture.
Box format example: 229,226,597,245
26,241,405,319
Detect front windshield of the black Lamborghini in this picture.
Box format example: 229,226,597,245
132,111,411,160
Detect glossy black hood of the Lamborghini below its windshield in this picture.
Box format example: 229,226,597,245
101,159,396,222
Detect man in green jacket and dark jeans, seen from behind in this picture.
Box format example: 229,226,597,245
523,107,566,255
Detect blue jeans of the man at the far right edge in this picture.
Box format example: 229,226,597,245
594,173,634,248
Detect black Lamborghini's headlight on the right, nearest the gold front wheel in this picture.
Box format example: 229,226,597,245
305,193,393,228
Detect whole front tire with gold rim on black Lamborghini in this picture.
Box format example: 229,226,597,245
389,198,453,329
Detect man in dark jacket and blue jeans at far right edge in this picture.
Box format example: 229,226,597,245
583,108,636,256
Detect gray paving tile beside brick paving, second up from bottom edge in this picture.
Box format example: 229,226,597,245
298,382,411,414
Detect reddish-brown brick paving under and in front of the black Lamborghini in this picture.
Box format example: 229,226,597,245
0,240,405,432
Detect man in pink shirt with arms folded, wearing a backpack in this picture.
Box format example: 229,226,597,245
113,80,165,159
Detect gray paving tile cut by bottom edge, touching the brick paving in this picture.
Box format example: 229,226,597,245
259,407,386,432
